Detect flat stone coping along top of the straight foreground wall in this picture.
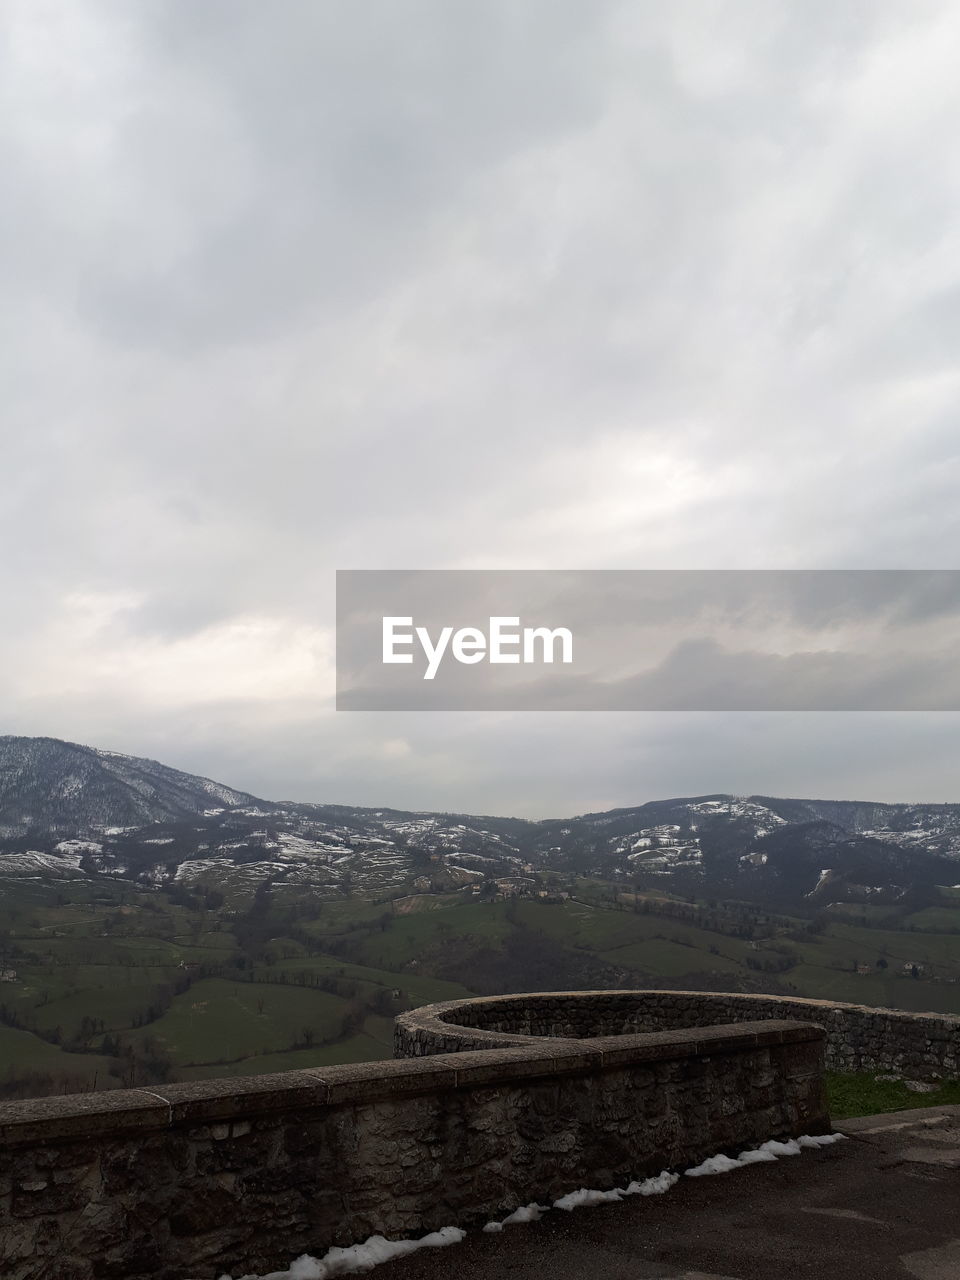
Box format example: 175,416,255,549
0,1018,826,1147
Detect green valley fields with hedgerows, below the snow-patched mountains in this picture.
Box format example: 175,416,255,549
0,879,960,1096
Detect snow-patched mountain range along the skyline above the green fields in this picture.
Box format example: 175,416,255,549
0,737,960,906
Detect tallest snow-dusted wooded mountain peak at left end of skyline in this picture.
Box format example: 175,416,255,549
0,737,261,836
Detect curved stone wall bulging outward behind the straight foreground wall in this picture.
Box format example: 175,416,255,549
394,991,960,1078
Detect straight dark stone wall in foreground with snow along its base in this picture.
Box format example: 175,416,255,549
0,1020,829,1280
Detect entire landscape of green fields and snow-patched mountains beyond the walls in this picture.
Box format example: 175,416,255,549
0,739,960,1097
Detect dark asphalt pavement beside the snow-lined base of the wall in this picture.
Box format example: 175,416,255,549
376,1107,960,1280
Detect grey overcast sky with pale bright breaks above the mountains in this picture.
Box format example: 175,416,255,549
0,0,960,815
